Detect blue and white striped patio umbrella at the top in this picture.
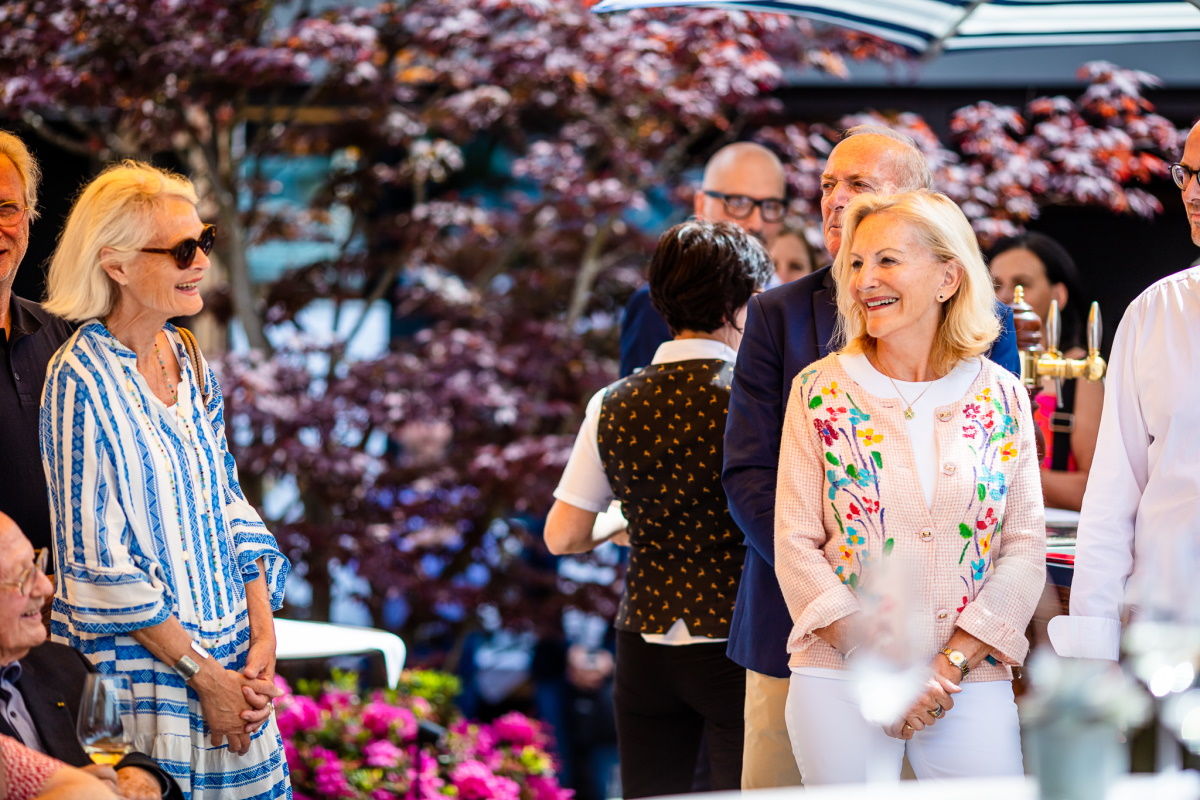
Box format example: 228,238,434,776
592,0,1200,56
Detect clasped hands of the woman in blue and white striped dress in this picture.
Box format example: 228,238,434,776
192,642,283,756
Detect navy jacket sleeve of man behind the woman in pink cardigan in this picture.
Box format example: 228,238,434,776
721,296,784,566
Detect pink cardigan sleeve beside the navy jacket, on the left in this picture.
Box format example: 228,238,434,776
775,378,859,651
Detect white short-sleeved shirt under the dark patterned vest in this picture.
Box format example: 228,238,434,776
554,339,738,645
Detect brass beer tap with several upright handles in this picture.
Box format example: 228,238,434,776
1012,285,1108,397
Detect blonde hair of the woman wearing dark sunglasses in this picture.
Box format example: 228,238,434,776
44,161,199,321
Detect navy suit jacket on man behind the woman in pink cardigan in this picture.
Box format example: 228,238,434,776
721,266,1020,678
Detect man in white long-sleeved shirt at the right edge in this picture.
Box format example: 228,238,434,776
1049,117,1200,660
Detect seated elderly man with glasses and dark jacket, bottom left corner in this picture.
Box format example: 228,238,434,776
0,513,182,800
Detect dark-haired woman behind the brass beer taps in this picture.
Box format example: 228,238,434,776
988,233,1104,511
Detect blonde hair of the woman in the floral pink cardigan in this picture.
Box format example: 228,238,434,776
833,190,1000,374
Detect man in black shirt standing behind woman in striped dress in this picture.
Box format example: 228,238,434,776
0,131,72,556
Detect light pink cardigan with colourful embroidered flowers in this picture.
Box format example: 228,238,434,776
775,355,1045,681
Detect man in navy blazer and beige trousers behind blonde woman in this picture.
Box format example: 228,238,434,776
722,126,1019,789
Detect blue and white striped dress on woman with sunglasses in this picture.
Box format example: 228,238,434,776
41,320,292,800
